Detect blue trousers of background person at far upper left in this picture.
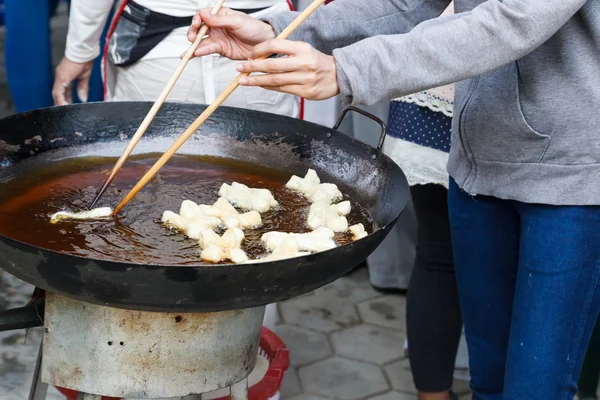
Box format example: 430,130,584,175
4,0,108,112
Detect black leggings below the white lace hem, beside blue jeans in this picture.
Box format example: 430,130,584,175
406,185,462,392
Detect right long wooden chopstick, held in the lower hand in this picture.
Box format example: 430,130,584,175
112,0,325,215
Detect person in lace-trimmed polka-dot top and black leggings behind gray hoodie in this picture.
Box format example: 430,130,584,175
384,5,462,400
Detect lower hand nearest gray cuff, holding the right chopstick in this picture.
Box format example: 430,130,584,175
237,39,339,100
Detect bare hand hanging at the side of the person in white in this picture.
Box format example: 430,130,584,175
52,57,94,106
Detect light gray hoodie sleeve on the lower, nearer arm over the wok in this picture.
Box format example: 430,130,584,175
333,0,587,104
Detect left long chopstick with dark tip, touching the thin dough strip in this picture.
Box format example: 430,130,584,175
90,0,225,210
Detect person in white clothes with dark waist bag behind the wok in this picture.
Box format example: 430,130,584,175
53,0,300,117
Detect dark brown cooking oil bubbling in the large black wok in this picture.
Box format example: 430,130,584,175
0,154,372,265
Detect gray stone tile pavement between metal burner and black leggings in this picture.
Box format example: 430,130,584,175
276,268,469,400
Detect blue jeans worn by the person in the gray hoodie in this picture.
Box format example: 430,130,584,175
448,180,600,400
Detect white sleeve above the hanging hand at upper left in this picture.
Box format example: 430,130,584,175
65,0,114,63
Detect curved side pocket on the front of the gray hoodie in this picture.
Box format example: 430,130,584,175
460,63,550,163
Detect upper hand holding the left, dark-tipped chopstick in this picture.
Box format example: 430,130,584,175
188,8,276,60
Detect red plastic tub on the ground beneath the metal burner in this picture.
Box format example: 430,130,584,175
56,327,290,400
